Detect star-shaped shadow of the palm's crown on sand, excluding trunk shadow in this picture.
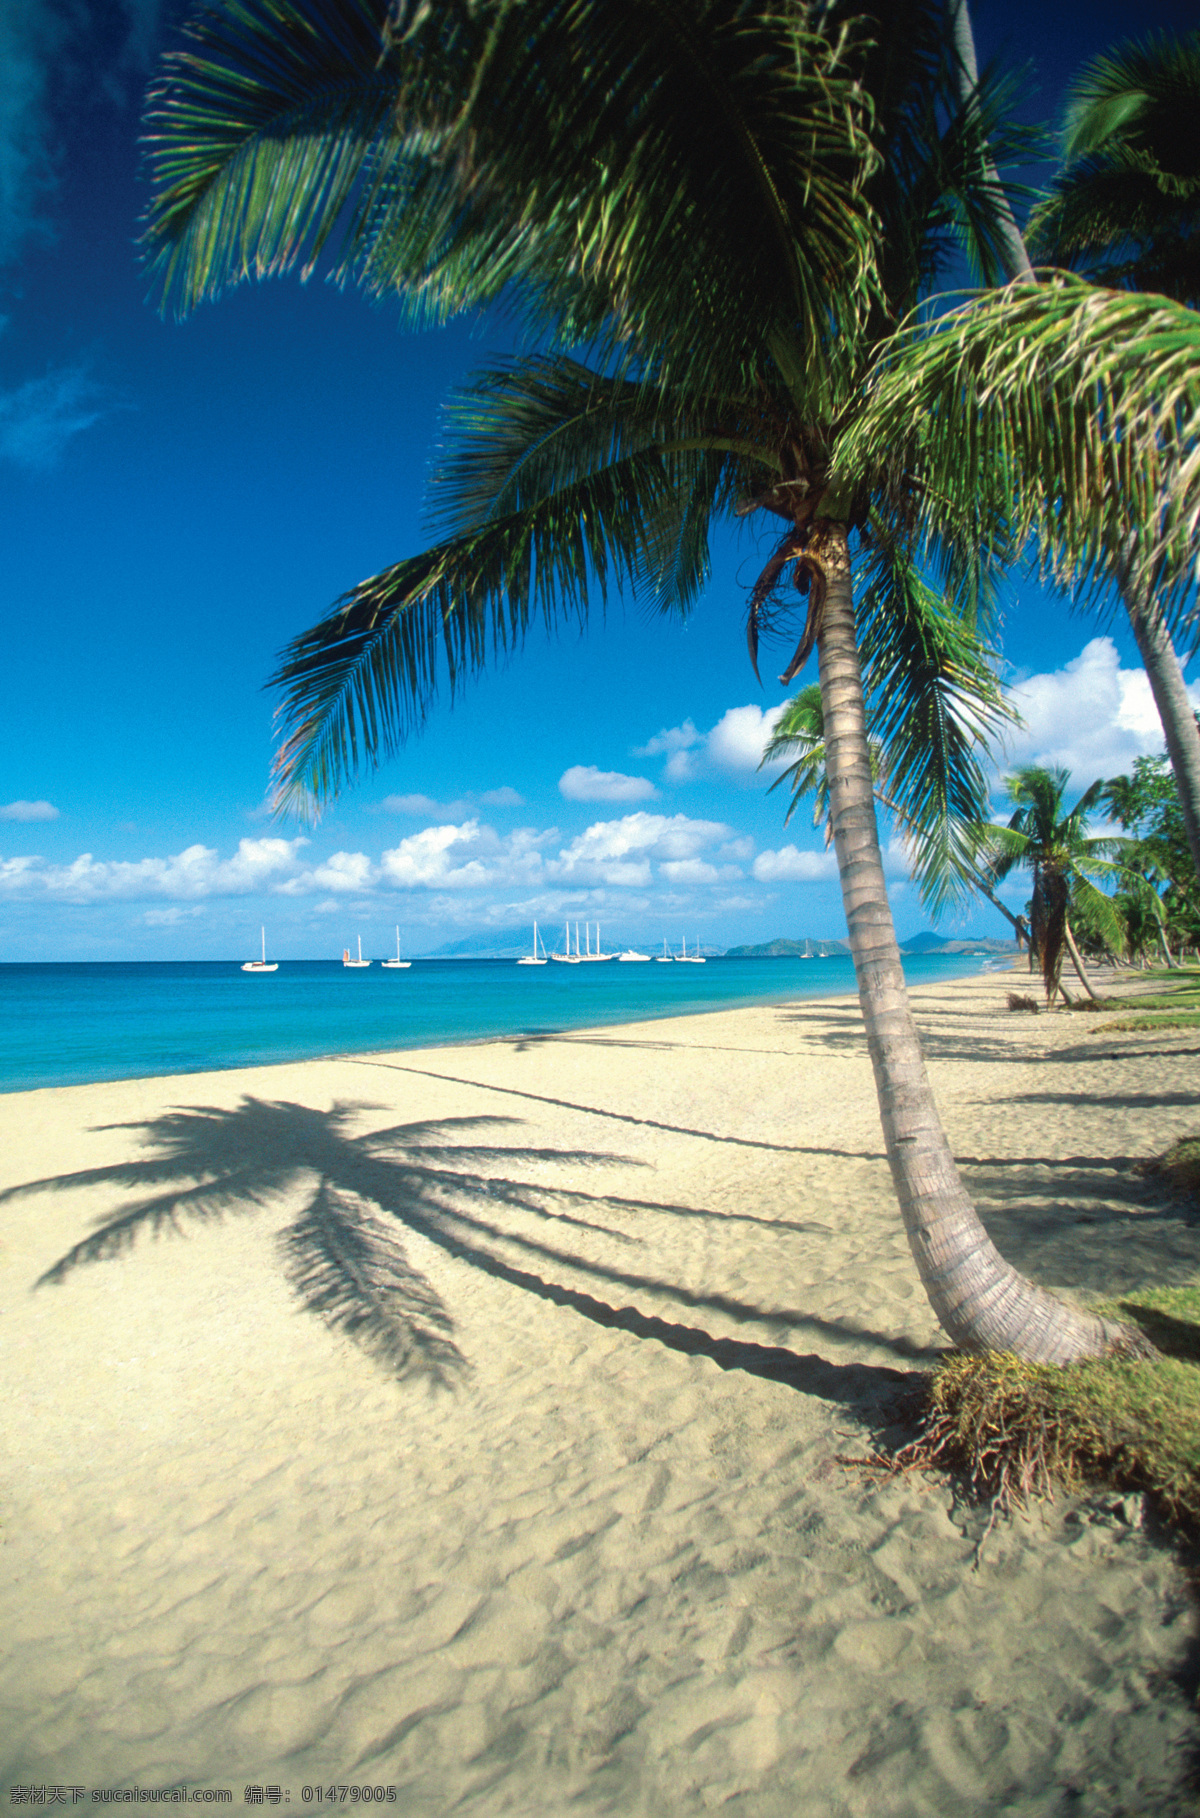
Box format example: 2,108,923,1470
11,1098,636,1383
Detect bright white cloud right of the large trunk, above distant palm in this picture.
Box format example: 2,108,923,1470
1007,638,1200,789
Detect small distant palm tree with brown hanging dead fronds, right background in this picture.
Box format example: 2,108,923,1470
985,764,1125,1004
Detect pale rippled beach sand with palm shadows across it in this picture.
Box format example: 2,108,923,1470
0,974,1200,1818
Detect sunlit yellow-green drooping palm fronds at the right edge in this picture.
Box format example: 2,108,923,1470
833,273,1200,613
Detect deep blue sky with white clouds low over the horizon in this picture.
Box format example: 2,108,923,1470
0,0,1200,960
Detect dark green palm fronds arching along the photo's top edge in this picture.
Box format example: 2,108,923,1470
145,0,875,401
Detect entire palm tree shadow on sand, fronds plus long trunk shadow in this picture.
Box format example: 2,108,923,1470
0,1096,913,1407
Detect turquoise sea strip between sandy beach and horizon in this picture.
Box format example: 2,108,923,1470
0,954,982,1093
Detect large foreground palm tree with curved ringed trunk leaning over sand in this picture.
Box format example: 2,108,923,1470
147,0,1118,1362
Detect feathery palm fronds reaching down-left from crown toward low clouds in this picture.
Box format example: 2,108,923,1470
273,360,760,811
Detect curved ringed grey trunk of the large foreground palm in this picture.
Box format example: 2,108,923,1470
809,524,1122,1364
